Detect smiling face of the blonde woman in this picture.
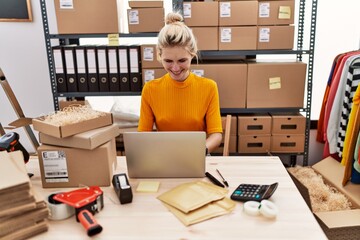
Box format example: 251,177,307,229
160,47,192,82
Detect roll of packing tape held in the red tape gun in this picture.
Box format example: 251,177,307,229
47,193,75,220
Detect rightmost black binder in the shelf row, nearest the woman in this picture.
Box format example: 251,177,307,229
129,45,142,92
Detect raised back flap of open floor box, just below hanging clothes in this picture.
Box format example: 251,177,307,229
312,157,360,208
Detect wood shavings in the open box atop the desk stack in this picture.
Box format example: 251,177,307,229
42,105,106,126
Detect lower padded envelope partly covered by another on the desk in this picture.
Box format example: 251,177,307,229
164,198,235,226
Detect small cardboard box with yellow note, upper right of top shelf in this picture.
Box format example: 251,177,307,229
257,0,295,25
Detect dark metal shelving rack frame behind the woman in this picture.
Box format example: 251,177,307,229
40,0,318,165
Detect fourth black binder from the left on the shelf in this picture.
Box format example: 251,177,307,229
86,46,100,92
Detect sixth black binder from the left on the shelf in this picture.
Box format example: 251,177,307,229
107,46,120,92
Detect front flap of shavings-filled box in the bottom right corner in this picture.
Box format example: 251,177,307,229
314,209,360,228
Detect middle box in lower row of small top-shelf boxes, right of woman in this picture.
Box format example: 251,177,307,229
219,26,257,50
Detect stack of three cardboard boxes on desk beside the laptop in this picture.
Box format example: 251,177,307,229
33,113,119,188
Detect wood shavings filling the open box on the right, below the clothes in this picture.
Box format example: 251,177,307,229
288,166,351,212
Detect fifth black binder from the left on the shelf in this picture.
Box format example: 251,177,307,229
96,45,110,92
